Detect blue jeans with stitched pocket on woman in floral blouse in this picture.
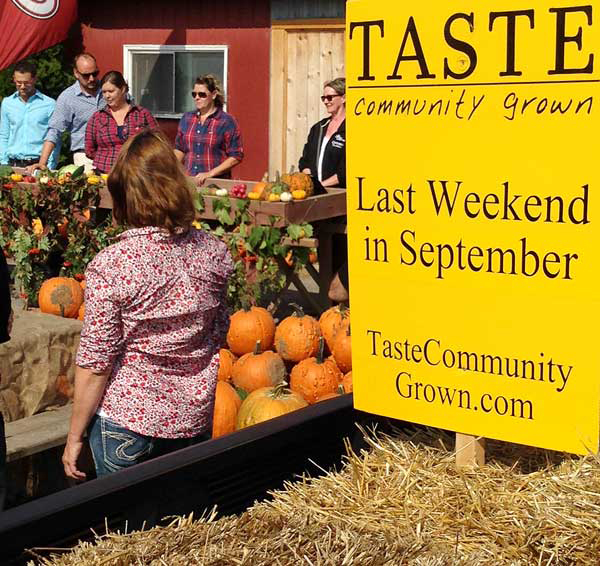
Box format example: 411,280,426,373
88,415,210,477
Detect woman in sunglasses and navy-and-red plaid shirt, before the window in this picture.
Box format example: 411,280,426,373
175,75,244,185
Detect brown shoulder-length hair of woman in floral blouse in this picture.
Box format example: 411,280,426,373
107,129,195,234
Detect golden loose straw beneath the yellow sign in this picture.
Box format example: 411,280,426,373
31,428,600,566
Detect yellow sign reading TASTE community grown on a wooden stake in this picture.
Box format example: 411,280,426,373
346,0,600,453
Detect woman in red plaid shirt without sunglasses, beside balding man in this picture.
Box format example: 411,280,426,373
85,71,158,173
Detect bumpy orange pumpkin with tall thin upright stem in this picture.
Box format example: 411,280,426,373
290,338,342,404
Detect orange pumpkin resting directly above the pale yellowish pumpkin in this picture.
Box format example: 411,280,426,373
231,342,286,392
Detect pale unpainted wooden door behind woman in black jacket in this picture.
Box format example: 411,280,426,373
269,23,344,178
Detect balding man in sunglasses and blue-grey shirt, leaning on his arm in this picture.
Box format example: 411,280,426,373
29,53,106,172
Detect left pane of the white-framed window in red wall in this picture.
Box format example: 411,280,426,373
131,53,175,114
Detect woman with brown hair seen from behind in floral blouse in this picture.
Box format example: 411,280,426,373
63,130,233,479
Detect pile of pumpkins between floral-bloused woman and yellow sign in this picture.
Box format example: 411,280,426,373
212,305,352,438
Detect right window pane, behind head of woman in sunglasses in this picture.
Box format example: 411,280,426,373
175,51,225,113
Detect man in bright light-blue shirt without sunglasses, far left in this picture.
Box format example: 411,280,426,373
0,61,60,167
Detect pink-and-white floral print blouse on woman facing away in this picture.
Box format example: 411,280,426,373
77,227,233,438
